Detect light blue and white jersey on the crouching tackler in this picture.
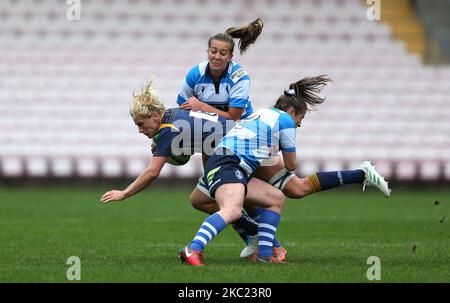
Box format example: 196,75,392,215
218,108,296,174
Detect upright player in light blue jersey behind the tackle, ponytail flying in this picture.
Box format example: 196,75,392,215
177,18,264,121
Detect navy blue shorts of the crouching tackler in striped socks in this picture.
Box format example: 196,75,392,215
200,152,250,198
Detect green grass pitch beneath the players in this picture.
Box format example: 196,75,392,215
0,187,450,283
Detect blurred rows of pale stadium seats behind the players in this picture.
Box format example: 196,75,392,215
0,0,450,180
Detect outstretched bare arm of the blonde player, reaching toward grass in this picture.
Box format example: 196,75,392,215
100,156,167,203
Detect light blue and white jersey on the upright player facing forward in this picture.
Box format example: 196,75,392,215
177,61,253,119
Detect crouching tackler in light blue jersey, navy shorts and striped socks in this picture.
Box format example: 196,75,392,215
179,83,306,266
